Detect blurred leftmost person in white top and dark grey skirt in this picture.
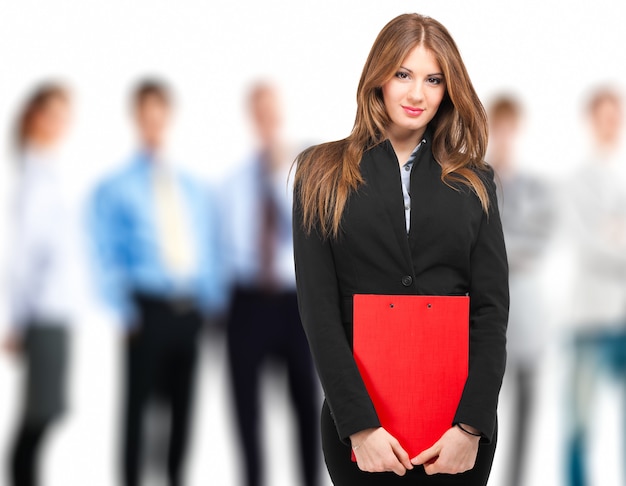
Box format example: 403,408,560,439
4,83,76,486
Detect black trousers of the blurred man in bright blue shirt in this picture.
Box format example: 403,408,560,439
122,295,202,486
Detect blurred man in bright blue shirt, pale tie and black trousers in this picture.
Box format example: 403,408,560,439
90,80,225,486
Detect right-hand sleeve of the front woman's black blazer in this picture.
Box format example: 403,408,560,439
454,172,509,441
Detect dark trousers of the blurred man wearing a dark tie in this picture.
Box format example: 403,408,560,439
227,290,320,486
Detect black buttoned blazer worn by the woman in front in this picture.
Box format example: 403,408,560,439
294,135,509,442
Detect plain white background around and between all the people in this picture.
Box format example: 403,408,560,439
0,0,626,486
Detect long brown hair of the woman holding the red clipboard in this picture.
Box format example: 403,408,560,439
295,14,489,237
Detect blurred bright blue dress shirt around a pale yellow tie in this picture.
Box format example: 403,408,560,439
88,153,226,326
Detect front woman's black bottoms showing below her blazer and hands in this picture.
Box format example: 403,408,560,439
322,402,497,486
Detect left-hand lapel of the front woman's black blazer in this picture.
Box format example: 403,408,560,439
367,140,413,268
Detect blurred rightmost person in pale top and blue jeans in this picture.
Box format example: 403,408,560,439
565,87,626,486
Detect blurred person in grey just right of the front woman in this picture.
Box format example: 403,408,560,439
487,95,555,486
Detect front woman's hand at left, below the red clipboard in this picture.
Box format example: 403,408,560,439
350,427,413,476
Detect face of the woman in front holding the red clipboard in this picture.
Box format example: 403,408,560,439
382,45,446,138
